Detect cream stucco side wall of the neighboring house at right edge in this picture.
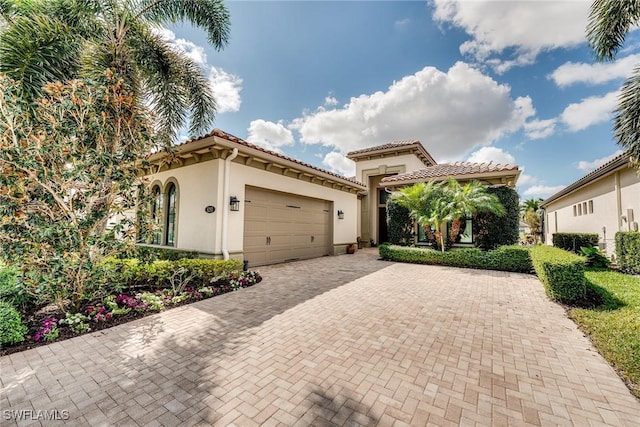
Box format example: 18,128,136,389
545,168,640,255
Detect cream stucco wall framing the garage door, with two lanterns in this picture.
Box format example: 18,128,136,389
225,163,358,258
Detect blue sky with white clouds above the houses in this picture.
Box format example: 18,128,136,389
161,0,640,198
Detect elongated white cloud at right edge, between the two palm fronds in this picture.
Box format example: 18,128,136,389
548,53,640,87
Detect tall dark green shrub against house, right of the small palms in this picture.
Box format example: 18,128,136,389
473,187,520,250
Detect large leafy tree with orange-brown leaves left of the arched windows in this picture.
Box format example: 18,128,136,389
0,72,153,308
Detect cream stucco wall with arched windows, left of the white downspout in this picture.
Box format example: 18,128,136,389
148,160,222,253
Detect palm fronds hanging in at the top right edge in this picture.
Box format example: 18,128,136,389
587,0,640,165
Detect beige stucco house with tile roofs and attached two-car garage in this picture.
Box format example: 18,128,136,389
147,129,520,266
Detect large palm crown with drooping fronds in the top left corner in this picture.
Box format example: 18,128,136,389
0,0,229,140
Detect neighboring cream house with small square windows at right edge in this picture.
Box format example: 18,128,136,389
541,154,640,256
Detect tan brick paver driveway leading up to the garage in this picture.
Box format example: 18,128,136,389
0,250,640,426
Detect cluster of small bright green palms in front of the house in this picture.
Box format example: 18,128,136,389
392,178,504,252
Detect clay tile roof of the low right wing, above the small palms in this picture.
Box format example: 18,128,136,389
382,162,519,182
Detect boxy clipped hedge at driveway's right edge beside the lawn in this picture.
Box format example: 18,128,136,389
531,245,586,302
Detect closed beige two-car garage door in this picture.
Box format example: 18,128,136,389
244,187,331,266
